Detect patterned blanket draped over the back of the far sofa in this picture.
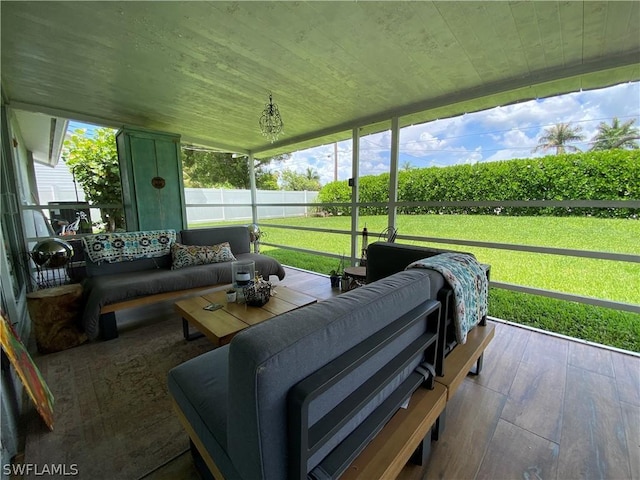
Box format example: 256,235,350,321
82,230,176,265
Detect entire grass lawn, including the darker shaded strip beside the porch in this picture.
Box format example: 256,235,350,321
194,215,640,352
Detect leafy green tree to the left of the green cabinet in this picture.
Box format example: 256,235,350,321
62,128,125,231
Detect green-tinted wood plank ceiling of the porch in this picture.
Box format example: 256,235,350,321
0,1,640,156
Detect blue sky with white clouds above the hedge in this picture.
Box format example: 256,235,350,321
274,82,640,184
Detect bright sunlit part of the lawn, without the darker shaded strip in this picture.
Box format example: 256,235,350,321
256,215,640,304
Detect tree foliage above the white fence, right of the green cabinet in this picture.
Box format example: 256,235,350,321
182,148,286,190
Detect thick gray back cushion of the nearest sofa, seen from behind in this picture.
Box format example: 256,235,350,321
227,271,430,479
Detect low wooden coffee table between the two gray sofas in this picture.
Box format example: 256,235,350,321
175,287,317,347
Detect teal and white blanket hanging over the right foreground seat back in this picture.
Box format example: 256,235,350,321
407,253,489,344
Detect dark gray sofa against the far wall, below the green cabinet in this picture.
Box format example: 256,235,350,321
82,226,285,339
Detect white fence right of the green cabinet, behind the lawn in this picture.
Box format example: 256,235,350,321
184,188,318,225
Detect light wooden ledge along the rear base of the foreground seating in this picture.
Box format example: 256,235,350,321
340,323,495,480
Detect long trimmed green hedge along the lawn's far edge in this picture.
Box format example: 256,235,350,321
318,149,640,218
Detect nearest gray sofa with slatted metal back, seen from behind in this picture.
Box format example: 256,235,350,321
168,269,445,480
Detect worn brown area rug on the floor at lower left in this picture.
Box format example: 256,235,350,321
24,315,212,479
